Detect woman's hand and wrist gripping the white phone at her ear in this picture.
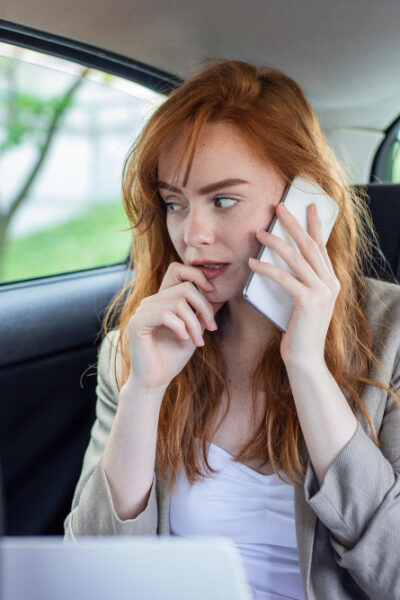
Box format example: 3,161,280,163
249,203,340,366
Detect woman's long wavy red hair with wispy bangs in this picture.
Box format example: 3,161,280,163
103,59,400,492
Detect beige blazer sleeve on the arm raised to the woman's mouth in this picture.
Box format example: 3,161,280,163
64,330,158,540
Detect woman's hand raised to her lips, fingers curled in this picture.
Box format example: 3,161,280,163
128,262,224,389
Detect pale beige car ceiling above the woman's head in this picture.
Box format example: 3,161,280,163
0,0,400,180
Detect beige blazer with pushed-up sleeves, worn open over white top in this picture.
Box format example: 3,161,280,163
64,278,400,600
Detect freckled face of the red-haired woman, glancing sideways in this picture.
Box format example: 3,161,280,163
158,123,285,302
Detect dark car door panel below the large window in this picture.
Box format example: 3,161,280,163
0,265,129,535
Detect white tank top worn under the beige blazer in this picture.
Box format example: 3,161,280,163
170,440,304,600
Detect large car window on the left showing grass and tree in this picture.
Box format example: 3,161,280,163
0,43,165,283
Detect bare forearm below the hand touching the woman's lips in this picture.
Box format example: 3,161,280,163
102,380,165,520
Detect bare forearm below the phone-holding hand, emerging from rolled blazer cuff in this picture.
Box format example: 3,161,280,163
286,362,358,486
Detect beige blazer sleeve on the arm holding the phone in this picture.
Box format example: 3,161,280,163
304,360,400,600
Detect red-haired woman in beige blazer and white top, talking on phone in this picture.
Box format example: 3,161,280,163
65,60,400,600
